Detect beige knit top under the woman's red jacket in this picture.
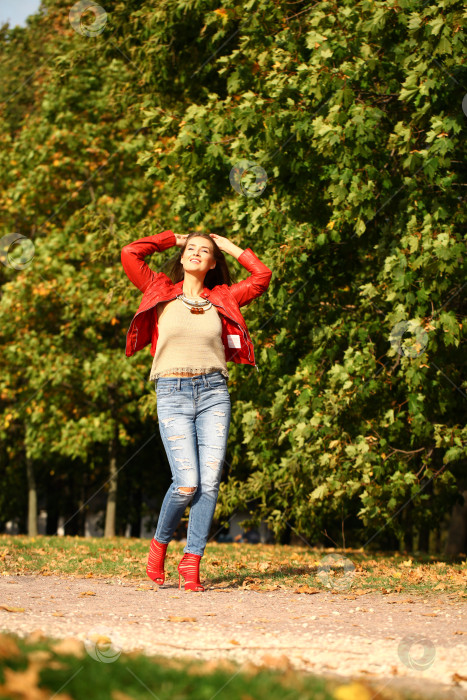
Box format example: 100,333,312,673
149,299,229,381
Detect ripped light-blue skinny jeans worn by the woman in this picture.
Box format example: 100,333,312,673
154,372,231,555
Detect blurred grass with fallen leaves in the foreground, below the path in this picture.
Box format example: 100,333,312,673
0,634,446,700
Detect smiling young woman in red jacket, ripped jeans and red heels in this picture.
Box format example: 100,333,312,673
122,231,272,591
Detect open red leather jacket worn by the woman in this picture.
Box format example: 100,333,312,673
121,230,272,369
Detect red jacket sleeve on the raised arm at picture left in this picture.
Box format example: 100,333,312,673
121,230,176,292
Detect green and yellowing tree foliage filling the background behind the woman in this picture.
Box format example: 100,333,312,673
0,0,467,547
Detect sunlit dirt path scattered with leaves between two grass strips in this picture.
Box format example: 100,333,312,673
0,575,467,700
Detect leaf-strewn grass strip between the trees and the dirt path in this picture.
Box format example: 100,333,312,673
0,535,467,596
